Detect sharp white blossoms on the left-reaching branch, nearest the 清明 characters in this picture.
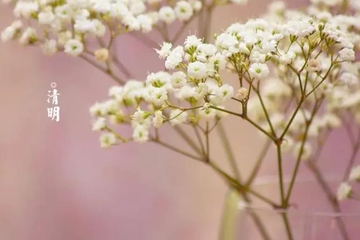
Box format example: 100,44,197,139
90,36,234,145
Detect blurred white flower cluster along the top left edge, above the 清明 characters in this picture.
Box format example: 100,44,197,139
1,0,245,56
